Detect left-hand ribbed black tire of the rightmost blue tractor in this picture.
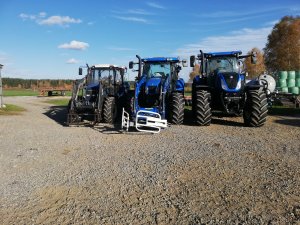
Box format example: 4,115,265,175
193,90,212,126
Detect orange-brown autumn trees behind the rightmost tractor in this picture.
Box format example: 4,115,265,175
189,16,300,81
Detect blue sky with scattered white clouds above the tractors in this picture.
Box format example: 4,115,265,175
0,0,300,80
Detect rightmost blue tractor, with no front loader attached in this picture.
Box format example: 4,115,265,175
190,50,268,127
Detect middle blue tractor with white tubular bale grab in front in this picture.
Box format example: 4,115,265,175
122,55,186,133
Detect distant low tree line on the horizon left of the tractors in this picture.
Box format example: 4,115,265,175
2,77,73,89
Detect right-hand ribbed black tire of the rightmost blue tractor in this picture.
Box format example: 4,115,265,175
243,90,268,127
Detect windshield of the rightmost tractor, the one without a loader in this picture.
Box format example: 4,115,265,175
207,57,239,74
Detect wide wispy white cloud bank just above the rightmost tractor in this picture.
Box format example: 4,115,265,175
175,27,272,57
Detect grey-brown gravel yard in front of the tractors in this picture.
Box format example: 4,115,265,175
0,97,300,225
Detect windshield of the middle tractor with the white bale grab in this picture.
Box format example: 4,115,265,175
143,62,171,78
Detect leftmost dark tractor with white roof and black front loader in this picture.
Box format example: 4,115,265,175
67,64,127,125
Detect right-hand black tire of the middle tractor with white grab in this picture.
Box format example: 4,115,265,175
169,92,185,125
